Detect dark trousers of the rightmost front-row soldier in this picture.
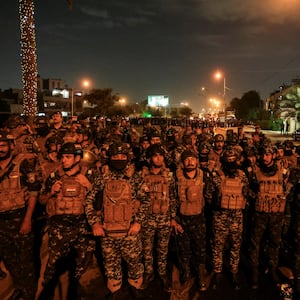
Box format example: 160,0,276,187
249,212,284,269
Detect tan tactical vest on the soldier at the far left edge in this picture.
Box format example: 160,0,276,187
0,159,26,212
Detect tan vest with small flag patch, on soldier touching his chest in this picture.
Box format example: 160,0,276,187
46,175,86,216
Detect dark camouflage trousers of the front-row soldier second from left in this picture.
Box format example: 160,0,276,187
44,215,90,285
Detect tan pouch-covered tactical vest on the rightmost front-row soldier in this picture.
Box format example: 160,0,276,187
255,169,286,213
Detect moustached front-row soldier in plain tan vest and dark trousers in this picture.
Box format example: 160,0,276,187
176,150,207,291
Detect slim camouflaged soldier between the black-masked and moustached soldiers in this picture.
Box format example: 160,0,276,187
141,144,181,291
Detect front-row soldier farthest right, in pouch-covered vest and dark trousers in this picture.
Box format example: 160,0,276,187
249,145,290,289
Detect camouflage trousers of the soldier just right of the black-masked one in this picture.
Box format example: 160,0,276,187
142,217,171,276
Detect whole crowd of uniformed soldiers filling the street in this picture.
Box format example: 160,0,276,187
0,111,300,300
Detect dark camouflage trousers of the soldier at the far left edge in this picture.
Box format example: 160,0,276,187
0,210,37,300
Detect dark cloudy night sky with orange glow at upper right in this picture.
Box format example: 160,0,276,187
0,0,300,112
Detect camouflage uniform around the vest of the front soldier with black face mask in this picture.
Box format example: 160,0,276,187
85,165,144,293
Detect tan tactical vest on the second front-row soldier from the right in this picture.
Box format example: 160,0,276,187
221,176,246,209
